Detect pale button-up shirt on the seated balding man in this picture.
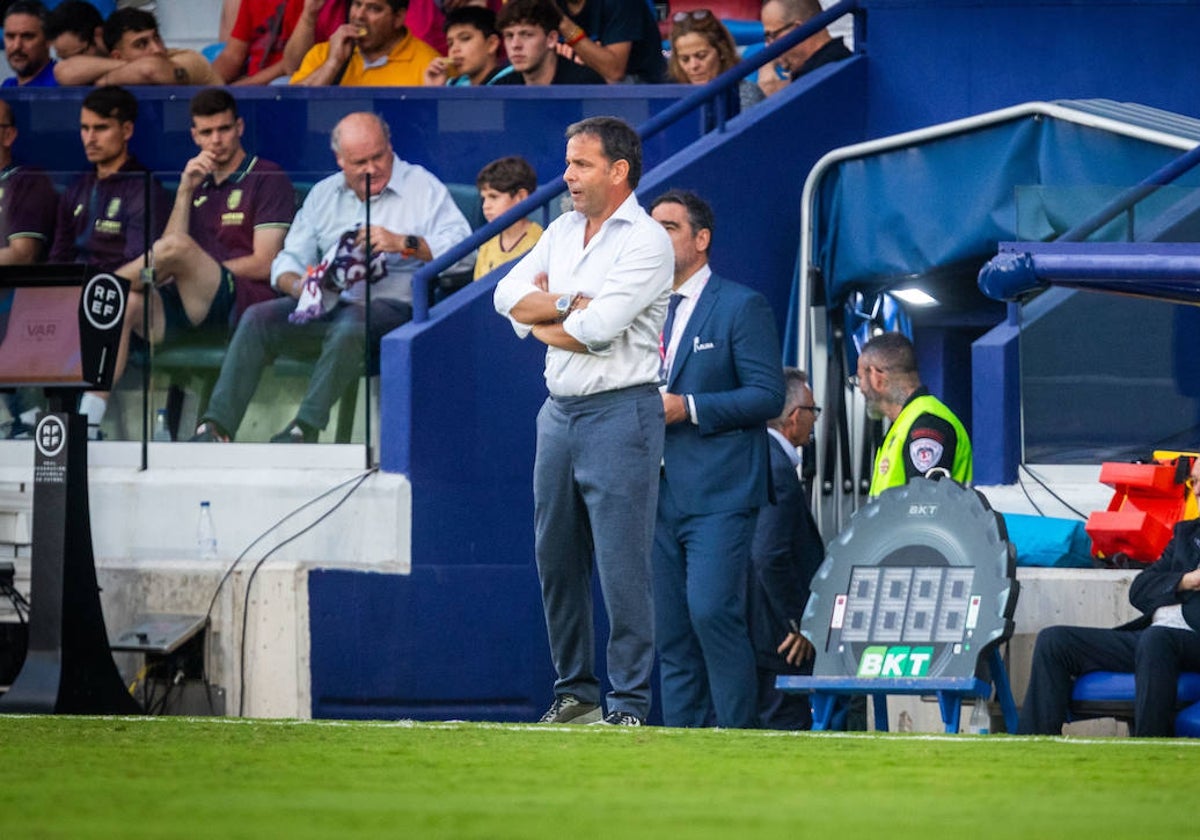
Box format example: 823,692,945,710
271,156,474,304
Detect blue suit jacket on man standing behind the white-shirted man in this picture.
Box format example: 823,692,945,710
662,274,784,515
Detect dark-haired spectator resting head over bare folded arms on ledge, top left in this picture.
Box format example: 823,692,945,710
54,8,223,85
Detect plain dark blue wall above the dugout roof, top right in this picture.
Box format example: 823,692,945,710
864,0,1200,137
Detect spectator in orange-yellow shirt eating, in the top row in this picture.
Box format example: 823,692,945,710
292,0,438,86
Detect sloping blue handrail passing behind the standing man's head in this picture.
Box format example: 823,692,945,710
413,0,863,324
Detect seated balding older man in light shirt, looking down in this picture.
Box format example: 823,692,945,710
192,113,470,443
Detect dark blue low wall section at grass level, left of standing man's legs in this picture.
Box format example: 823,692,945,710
308,564,554,720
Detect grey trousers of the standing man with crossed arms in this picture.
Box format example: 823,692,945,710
533,385,664,720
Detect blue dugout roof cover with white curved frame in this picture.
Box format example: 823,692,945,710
799,100,1200,347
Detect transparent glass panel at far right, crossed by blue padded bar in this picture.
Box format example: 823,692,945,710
1018,186,1200,463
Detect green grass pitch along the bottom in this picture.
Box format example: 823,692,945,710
0,716,1200,840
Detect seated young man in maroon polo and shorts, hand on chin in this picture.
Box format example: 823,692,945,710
88,88,295,436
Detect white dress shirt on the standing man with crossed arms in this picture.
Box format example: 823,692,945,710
493,194,678,397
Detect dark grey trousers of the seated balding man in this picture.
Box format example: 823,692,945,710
203,298,413,434
